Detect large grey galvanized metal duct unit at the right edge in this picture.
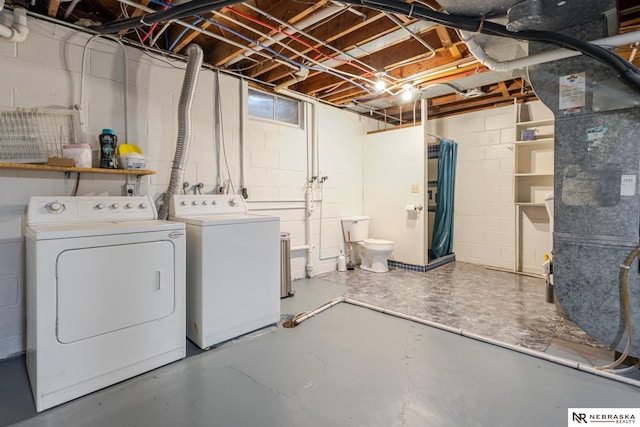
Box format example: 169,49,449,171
529,0,640,362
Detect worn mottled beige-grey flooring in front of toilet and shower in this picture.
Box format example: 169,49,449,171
318,262,613,364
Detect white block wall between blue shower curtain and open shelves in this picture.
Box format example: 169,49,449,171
429,107,515,269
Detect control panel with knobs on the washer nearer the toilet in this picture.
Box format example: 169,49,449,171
169,194,247,217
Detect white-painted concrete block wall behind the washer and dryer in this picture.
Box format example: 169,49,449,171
0,18,379,359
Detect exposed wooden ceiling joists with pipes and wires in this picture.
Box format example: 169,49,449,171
33,0,640,123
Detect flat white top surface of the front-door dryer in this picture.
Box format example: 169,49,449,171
27,220,185,240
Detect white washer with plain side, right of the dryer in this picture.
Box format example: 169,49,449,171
169,194,280,348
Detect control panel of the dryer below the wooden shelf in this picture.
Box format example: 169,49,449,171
27,196,158,224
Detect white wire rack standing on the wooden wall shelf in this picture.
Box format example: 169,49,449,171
0,108,80,163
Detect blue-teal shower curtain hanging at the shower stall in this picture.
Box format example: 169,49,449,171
431,139,458,258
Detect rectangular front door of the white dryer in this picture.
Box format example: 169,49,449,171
56,241,175,344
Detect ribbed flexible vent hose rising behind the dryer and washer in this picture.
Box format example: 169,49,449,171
158,44,203,220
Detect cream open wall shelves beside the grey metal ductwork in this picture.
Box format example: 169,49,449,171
513,115,554,205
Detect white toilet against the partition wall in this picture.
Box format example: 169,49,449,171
342,216,393,273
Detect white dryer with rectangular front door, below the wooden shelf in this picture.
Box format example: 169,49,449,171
26,197,186,412
